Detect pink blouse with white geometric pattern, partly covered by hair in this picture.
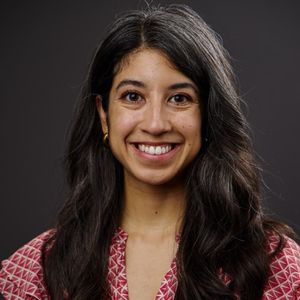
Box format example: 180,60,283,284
0,229,300,300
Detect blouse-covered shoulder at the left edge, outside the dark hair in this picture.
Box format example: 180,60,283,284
0,229,55,299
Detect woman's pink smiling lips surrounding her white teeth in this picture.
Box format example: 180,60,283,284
129,142,180,161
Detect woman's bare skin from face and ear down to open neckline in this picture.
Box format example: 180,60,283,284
97,48,201,300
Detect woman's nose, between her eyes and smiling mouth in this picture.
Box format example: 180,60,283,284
141,99,172,135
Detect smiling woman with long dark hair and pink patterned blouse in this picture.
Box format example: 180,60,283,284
0,5,300,300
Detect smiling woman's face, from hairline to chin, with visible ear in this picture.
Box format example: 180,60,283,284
97,49,201,185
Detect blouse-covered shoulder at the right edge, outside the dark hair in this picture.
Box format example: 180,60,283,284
263,235,300,300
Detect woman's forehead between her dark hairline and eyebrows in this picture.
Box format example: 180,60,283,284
113,48,196,86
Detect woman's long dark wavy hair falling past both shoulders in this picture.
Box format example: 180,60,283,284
43,5,292,300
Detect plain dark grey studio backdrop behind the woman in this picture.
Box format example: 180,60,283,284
0,0,300,259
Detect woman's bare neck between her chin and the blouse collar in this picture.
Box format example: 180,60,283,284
121,178,185,236
